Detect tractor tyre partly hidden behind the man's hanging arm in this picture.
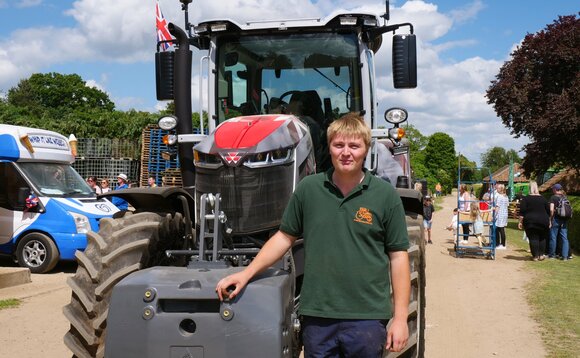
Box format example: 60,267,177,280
384,212,425,358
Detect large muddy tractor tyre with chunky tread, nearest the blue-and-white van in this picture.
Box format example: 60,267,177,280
63,212,184,358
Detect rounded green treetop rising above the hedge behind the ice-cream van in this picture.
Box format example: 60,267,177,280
7,72,115,112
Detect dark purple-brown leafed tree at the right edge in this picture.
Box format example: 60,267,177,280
487,15,580,173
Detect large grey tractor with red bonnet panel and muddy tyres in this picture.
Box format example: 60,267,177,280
64,0,425,358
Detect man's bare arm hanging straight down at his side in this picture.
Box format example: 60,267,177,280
386,251,411,352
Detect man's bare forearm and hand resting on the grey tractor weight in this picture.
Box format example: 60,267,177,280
215,230,296,301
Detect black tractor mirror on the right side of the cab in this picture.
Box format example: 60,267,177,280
393,34,417,88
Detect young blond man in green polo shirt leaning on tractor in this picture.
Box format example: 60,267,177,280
216,113,410,358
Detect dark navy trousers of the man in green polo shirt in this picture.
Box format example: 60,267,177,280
302,316,387,358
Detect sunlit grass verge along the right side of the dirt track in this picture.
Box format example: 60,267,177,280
506,220,580,358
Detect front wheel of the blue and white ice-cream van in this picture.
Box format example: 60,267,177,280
16,232,60,273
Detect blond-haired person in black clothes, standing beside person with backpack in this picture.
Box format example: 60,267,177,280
518,180,550,261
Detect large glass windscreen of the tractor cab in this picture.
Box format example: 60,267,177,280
216,33,362,125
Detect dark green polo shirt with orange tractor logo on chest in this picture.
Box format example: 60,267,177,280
280,169,409,319
